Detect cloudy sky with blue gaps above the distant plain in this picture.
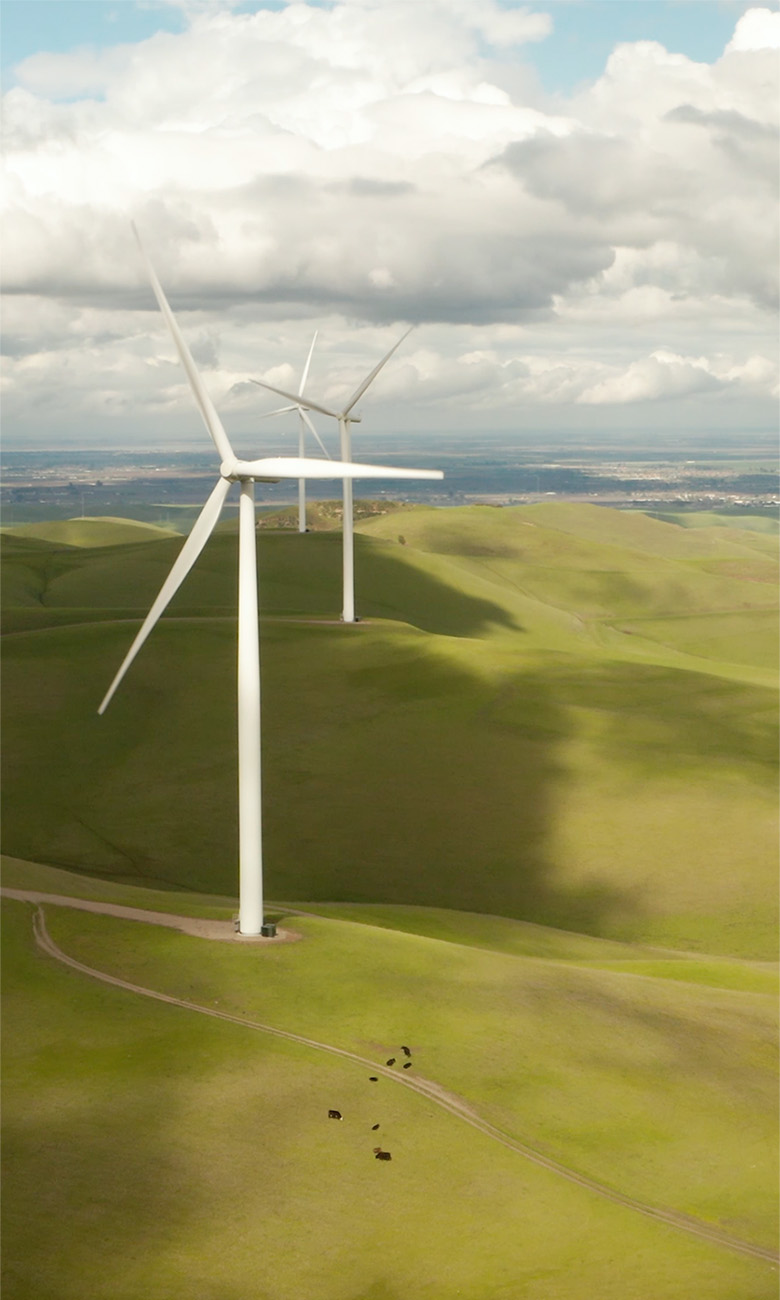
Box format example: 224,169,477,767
3,0,780,454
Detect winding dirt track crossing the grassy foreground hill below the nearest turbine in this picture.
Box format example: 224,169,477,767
9,889,780,1265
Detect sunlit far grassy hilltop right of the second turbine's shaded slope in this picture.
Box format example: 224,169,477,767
360,504,779,680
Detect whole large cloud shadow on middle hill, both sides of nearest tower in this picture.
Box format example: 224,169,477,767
4,619,641,933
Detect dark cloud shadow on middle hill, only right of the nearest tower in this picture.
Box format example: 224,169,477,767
265,640,641,933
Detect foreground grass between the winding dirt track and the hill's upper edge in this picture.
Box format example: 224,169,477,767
35,909,777,1245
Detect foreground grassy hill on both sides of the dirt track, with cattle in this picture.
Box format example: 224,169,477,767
3,905,776,1300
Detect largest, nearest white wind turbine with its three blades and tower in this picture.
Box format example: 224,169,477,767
98,228,443,935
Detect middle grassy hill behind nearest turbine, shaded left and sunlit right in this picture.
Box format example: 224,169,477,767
4,619,775,957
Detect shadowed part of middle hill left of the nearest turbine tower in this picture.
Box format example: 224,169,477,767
3,620,237,893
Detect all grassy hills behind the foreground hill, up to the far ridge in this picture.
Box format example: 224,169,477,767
5,506,776,957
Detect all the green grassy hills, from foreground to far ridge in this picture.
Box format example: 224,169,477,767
3,504,777,1300
